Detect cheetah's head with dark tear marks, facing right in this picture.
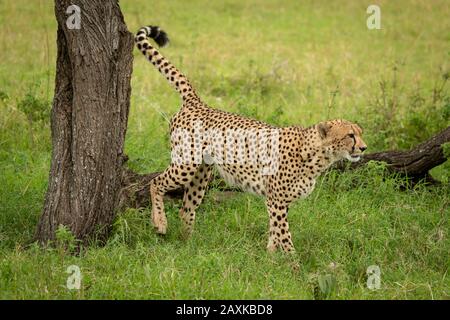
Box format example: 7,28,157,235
317,120,367,162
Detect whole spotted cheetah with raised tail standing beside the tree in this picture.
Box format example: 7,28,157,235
135,26,367,252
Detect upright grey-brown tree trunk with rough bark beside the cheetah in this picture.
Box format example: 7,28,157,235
36,0,133,243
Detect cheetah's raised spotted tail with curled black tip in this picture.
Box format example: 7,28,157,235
134,26,198,100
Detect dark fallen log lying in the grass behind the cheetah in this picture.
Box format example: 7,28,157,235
119,127,450,210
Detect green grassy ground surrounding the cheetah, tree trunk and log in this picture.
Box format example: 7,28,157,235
0,0,450,299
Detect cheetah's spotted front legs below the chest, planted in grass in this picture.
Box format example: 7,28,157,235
266,200,295,252
